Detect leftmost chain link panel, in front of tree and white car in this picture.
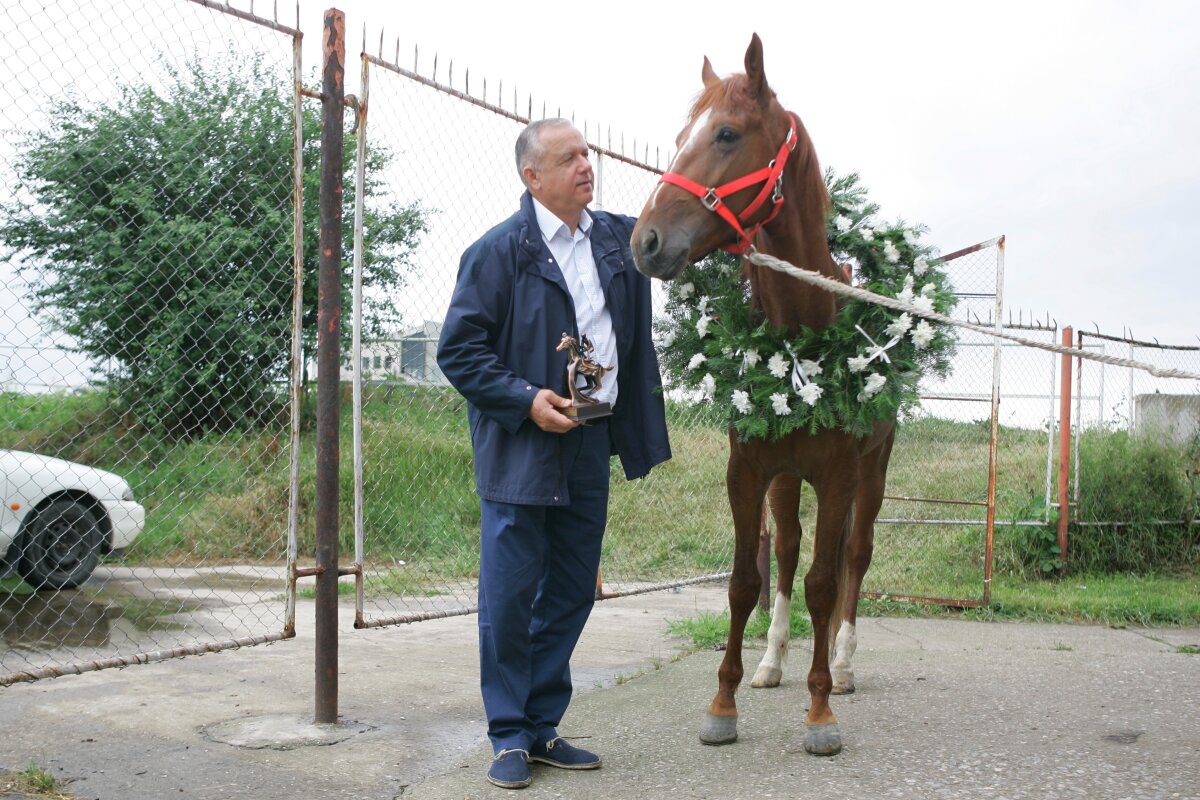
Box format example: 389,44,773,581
0,0,316,682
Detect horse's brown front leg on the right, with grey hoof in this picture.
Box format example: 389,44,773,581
804,470,858,756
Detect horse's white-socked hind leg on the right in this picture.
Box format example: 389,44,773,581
829,427,895,694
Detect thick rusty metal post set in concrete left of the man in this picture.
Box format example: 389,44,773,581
314,8,346,723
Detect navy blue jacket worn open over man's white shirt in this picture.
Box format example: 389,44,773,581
438,192,671,505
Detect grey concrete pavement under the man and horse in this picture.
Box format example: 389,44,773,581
0,585,1200,800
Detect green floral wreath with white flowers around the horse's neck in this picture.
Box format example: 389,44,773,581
655,170,956,440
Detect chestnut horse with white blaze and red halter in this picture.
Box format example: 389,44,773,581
632,35,895,756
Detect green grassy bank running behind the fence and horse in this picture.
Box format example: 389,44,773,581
0,385,1200,623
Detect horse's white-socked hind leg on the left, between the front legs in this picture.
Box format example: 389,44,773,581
750,475,800,688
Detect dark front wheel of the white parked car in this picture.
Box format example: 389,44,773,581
17,500,102,589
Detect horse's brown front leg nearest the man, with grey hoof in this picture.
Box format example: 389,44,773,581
700,448,769,745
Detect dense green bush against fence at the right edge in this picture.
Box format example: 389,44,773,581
1067,429,1200,573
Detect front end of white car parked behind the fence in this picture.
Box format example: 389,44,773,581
0,450,145,589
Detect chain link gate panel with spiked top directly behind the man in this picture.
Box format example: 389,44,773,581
343,47,732,625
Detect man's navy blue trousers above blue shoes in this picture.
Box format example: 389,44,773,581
479,421,610,752
